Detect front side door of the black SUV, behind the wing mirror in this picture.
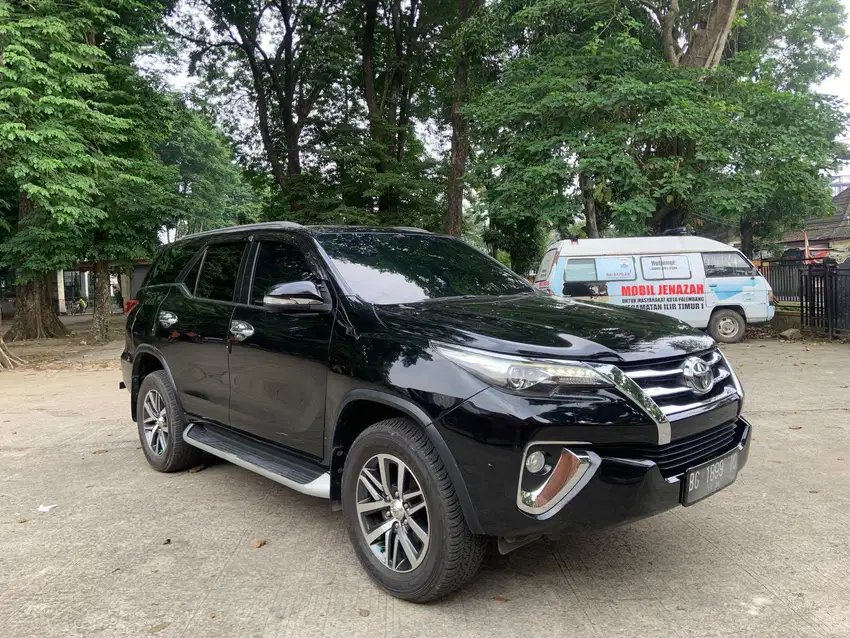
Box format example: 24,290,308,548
230,236,333,457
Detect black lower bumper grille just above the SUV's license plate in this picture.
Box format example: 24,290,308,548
595,422,740,478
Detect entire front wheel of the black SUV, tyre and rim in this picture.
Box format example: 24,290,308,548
342,418,486,603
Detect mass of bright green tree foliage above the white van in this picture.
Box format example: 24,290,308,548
469,0,847,260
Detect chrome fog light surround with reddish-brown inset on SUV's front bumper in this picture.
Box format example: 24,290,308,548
517,441,602,516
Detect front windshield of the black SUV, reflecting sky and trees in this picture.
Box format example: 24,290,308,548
317,232,533,305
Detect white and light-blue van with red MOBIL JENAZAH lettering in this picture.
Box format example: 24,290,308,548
534,237,775,343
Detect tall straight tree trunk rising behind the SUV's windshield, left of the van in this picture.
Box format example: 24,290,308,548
443,0,481,237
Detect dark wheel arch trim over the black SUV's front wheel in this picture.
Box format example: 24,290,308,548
328,389,482,534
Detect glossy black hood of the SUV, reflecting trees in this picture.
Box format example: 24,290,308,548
373,294,714,361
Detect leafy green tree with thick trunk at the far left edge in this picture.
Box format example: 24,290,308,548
0,0,134,339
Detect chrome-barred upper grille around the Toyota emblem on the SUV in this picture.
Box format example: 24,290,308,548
619,350,737,421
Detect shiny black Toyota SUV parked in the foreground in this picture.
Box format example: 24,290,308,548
122,222,751,602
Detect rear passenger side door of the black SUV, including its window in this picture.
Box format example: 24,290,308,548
156,241,248,423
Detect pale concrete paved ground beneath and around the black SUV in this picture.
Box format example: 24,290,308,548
0,341,850,638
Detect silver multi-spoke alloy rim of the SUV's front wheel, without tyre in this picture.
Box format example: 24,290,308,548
356,454,430,573
